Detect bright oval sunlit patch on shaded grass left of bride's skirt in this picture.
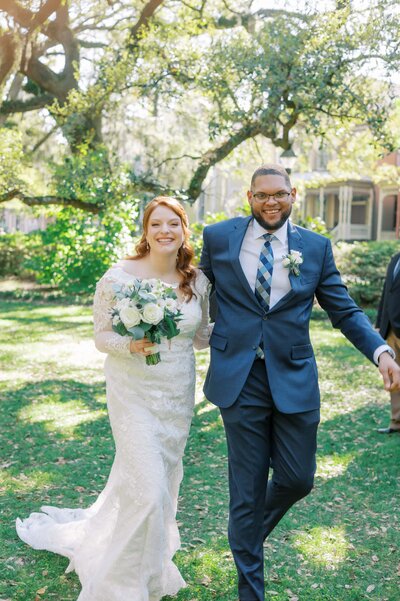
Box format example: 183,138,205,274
18,401,107,434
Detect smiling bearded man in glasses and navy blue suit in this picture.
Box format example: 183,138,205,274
201,165,400,601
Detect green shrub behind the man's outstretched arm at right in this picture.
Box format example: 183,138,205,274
334,241,400,307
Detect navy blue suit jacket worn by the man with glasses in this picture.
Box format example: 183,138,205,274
201,217,385,413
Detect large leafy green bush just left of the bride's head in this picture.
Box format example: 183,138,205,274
26,201,136,293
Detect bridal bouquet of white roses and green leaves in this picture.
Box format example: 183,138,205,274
111,279,182,365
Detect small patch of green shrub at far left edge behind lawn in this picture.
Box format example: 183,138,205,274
0,232,34,277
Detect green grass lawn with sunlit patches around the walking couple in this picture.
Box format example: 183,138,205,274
0,301,400,601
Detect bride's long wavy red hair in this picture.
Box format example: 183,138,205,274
125,196,196,301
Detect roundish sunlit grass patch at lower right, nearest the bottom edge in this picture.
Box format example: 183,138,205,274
294,526,350,570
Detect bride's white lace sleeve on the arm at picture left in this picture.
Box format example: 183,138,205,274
93,275,131,357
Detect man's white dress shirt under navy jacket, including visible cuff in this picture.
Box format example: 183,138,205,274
239,219,394,365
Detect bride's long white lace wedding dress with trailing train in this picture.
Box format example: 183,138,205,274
17,267,209,601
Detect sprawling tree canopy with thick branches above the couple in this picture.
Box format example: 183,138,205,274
0,0,400,214
